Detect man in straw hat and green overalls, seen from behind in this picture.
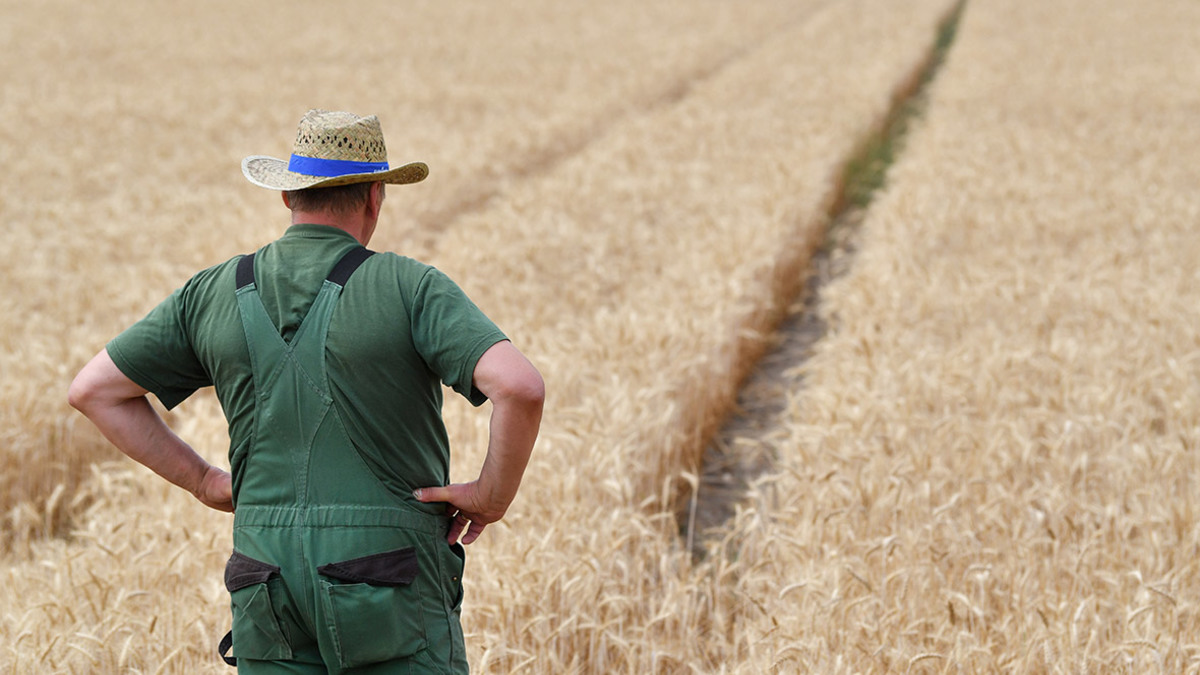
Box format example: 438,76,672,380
70,110,544,674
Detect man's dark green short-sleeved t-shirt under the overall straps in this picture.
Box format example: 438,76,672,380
107,225,505,495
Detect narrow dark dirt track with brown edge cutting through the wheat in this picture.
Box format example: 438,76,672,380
679,1,965,557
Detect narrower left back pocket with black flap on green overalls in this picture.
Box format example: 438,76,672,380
224,551,292,661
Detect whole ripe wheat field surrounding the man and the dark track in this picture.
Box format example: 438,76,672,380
0,0,1200,674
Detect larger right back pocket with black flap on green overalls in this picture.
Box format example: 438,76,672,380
317,548,426,668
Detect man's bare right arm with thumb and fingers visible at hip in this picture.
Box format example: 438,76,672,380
414,340,546,544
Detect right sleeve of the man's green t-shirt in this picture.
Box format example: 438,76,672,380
413,268,508,406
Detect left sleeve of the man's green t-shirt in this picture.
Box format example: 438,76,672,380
106,288,211,410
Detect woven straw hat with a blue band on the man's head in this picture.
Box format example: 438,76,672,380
241,110,430,190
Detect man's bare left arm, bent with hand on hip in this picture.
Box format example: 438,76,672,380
67,350,233,512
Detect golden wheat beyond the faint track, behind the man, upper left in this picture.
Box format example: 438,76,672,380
0,1,803,545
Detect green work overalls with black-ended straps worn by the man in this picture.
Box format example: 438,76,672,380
221,247,468,674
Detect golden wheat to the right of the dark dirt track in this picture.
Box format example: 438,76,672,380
724,0,1200,673
